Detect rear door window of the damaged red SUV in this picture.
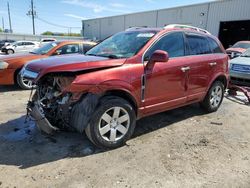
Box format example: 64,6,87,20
186,34,212,55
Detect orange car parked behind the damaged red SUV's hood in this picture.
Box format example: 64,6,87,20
0,41,96,89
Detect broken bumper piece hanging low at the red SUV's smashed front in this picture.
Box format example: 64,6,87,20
27,102,59,135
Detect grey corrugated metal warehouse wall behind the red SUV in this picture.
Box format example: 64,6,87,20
82,0,250,39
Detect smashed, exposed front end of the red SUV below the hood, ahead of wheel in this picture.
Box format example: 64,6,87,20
27,76,98,134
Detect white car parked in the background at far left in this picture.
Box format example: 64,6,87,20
1,41,39,54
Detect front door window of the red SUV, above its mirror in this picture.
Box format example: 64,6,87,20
145,32,185,60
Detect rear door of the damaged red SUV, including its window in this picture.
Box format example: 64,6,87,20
186,33,216,102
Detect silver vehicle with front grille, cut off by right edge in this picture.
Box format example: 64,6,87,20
229,48,250,86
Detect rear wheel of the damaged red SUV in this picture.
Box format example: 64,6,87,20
200,81,225,113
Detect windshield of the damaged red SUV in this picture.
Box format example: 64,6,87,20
86,31,156,58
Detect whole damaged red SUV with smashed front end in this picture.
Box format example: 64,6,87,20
21,26,228,149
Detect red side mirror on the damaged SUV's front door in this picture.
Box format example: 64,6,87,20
146,50,169,70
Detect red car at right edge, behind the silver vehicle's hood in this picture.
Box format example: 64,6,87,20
226,41,250,59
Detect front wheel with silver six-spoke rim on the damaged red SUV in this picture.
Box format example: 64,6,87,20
85,96,136,149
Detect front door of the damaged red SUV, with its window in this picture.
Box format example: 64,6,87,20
144,32,188,114
